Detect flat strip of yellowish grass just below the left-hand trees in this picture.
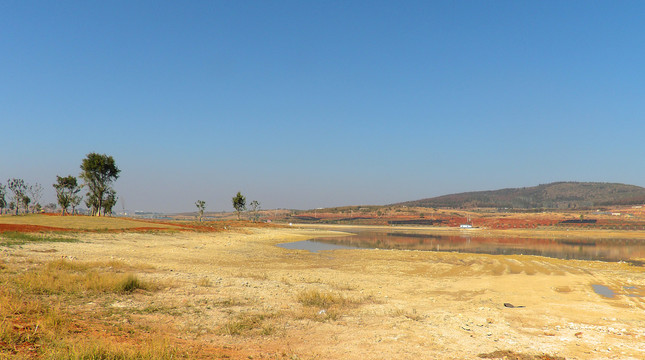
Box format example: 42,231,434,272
0,214,180,230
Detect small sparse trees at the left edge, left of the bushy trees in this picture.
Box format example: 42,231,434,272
0,178,43,215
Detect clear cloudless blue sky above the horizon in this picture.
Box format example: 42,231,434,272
0,0,645,212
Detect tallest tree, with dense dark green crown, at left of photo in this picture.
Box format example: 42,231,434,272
81,153,121,216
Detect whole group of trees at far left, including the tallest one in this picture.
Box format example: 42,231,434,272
0,153,121,216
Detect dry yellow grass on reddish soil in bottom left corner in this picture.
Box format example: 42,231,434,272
0,260,186,360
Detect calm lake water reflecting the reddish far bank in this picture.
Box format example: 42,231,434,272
278,228,645,265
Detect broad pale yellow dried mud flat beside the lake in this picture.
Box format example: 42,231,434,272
1,228,645,359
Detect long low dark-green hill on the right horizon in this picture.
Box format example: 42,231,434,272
395,182,645,209
